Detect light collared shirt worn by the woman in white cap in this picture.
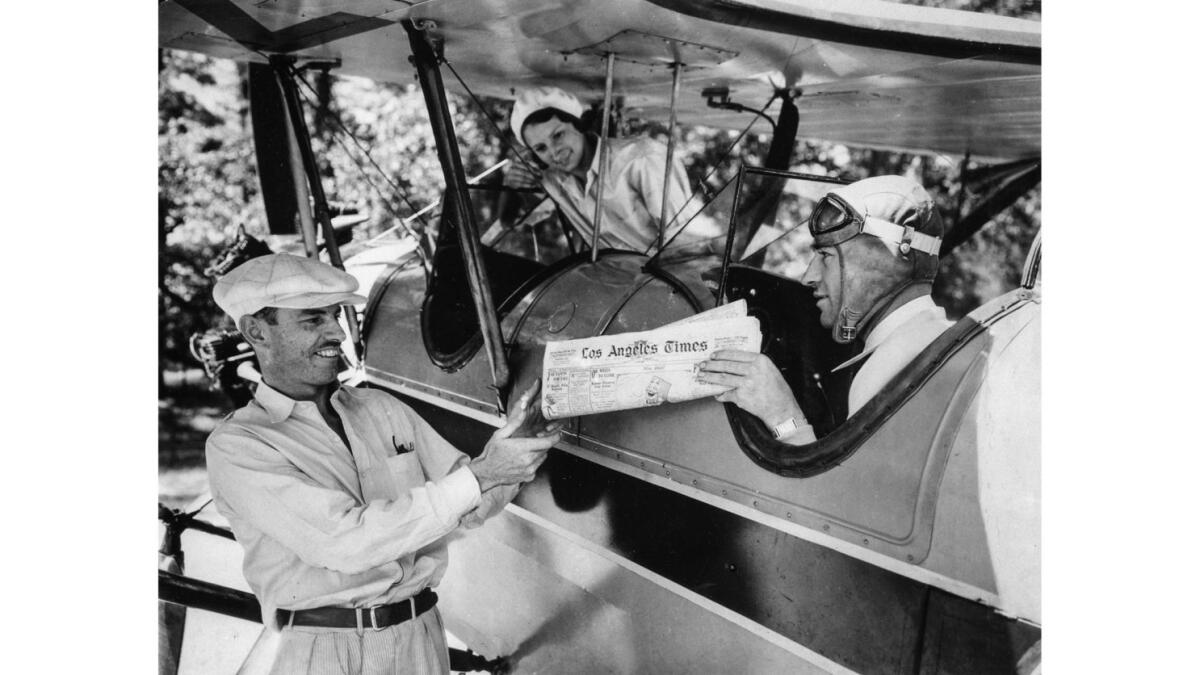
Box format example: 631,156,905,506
542,136,720,252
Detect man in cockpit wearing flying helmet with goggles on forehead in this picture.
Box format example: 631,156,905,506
700,175,952,444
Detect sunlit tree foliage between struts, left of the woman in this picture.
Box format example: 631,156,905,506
158,49,503,368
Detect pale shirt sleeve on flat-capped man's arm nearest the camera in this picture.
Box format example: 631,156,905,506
206,420,479,574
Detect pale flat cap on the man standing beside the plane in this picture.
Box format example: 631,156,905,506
212,253,367,321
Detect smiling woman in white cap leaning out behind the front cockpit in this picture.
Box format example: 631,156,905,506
504,86,720,252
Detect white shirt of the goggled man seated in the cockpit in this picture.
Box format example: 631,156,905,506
780,295,954,446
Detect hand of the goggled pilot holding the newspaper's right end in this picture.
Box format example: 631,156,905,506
696,350,808,426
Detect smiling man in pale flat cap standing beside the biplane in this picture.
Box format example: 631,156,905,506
206,253,558,674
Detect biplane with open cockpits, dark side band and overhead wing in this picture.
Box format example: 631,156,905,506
158,0,1042,674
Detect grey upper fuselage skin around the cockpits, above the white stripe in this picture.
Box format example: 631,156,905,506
367,255,1032,586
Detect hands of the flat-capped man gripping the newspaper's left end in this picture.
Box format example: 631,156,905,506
468,380,562,492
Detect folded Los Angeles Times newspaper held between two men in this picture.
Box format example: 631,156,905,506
541,300,762,419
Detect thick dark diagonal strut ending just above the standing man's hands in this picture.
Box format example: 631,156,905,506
401,19,509,411
